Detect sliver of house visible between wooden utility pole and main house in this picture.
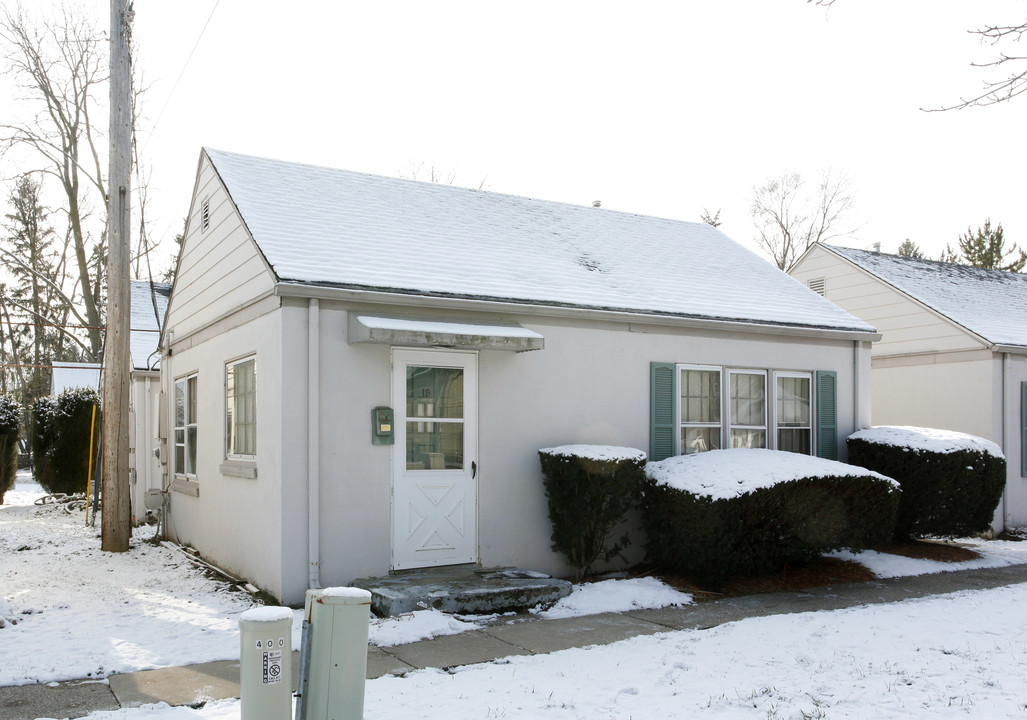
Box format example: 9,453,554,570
128,280,172,522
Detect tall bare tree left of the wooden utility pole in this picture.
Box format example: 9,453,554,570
0,2,109,357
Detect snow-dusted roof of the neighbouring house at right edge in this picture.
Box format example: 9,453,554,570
825,245,1027,347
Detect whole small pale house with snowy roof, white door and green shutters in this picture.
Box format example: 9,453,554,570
161,150,878,604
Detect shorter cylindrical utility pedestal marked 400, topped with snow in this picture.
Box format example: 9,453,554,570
239,607,293,720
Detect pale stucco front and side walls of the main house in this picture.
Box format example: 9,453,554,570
162,299,869,604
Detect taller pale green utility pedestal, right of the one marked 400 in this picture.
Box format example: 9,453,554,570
295,588,371,720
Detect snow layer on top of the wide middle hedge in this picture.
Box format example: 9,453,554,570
645,448,899,500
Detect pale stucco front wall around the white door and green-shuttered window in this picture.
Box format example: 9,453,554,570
306,303,869,599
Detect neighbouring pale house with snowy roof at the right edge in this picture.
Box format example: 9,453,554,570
791,245,1027,530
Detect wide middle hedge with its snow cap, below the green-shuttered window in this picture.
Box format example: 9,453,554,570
642,449,899,584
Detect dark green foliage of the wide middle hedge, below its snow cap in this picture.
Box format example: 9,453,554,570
642,453,900,584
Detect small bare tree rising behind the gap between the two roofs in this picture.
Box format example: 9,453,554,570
750,170,857,270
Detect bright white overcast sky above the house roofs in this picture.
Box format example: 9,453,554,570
2,0,1027,271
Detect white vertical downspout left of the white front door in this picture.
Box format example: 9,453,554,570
307,298,320,590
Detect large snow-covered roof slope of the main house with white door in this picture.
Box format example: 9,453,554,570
204,149,874,333
